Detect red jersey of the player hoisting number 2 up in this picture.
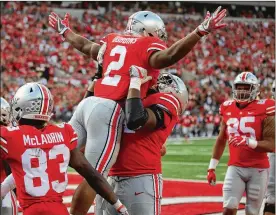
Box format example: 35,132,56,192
109,93,180,176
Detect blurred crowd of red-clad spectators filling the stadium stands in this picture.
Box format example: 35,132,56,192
0,2,275,136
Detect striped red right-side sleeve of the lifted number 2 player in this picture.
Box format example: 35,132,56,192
141,37,167,67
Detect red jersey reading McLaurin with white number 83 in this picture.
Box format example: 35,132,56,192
0,124,77,208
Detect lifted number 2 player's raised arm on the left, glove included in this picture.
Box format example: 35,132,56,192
49,12,100,60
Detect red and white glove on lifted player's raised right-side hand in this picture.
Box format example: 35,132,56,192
196,6,227,37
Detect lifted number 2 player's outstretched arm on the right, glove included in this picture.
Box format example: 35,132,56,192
149,7,226,69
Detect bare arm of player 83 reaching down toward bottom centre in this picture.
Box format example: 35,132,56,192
70,149,127,215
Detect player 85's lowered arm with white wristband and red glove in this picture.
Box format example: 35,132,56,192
207,120,227,185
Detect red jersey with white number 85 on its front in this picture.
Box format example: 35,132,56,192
220,99,275,168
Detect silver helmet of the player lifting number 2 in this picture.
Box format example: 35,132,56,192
157,72,189,115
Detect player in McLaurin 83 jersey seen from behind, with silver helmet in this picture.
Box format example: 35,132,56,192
0,83,128,215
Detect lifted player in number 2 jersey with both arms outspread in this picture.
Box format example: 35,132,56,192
49,7,226,215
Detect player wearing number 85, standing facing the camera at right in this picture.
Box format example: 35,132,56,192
207,72,275,215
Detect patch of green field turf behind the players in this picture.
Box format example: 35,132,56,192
162,139,228,181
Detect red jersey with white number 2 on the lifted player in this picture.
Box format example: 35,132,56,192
94,33,167,101
